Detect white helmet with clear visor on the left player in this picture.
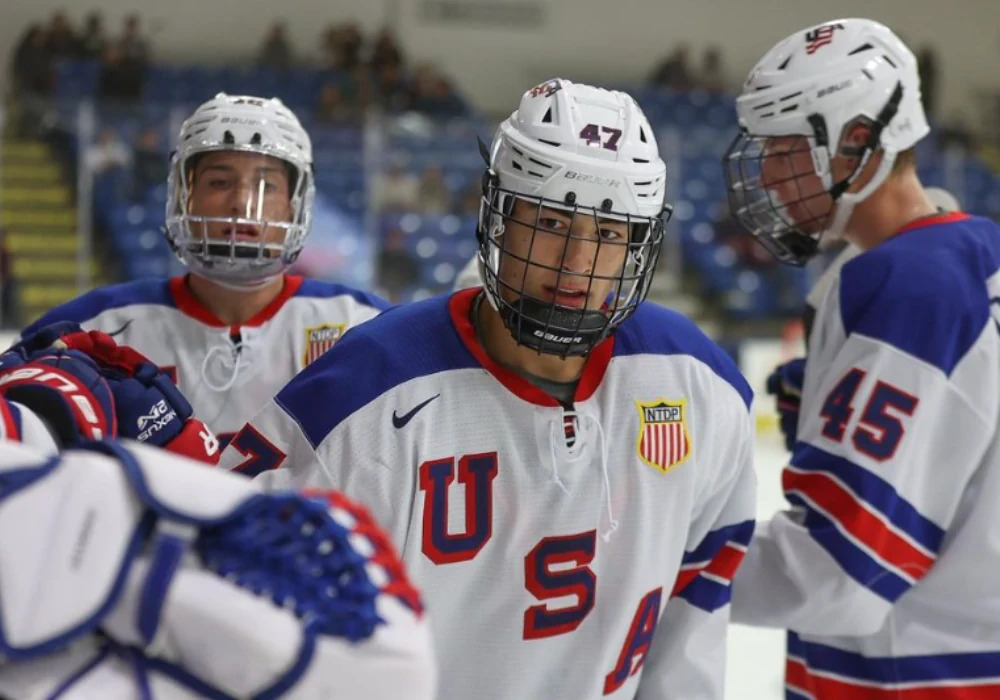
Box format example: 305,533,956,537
166,93,316,288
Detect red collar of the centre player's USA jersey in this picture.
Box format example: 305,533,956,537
448,287,615,407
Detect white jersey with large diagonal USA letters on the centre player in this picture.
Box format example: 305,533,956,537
221,289,755,700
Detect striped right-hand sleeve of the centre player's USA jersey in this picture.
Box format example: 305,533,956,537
636,382,756,700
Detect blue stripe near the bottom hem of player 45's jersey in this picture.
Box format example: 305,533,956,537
788,633,1000,684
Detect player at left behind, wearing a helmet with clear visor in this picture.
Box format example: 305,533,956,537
25,94,385,443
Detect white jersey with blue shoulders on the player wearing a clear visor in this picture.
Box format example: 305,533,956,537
22,275,387,445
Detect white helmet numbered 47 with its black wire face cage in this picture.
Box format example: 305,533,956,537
477,78,670,357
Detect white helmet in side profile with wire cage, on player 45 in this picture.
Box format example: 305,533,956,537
725,19,930,264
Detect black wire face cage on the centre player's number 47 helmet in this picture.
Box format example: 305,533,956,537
477,183,671,358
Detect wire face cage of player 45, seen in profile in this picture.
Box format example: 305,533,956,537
724,132,835,265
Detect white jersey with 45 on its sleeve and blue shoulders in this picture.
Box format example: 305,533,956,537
733,213,1000,700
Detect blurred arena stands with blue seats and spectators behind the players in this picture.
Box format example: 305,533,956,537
0,5,1000,356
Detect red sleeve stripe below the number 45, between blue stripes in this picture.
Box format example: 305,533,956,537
781,469,934,580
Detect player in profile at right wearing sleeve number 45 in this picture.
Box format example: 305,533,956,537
727,19,1000,700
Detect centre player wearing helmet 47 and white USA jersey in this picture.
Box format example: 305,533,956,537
220,79,754,700
